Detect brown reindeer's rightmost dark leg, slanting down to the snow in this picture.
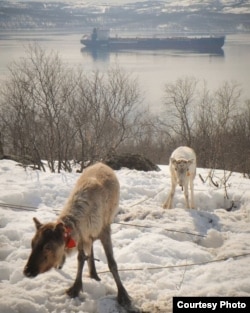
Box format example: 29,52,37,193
100,226,131,307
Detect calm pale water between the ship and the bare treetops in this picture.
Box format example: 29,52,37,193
0,32,250,110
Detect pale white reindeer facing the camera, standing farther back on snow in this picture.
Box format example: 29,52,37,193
163,147,196,209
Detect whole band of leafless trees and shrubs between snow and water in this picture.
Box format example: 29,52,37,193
0,44,250,175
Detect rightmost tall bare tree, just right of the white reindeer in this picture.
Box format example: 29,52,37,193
194,78,242,170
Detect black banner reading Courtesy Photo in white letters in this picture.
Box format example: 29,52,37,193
173,297,250,313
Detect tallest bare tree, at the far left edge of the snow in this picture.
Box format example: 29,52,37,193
2,44,75,171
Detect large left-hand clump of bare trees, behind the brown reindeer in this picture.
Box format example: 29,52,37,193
1,44,143,172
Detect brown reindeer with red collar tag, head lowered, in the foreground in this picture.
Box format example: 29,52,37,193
24,163,131,308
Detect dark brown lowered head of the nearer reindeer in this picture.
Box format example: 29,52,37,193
23,218,65,277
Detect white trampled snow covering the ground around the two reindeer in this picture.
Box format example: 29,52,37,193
0,160,250,313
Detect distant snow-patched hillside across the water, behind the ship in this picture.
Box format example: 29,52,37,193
0,0,250,34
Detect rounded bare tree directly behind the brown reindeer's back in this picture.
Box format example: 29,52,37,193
73,67,142,168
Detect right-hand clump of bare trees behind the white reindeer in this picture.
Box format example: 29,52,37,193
160,77,249,172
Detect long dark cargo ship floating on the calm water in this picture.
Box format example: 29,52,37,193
81,28,225,52
